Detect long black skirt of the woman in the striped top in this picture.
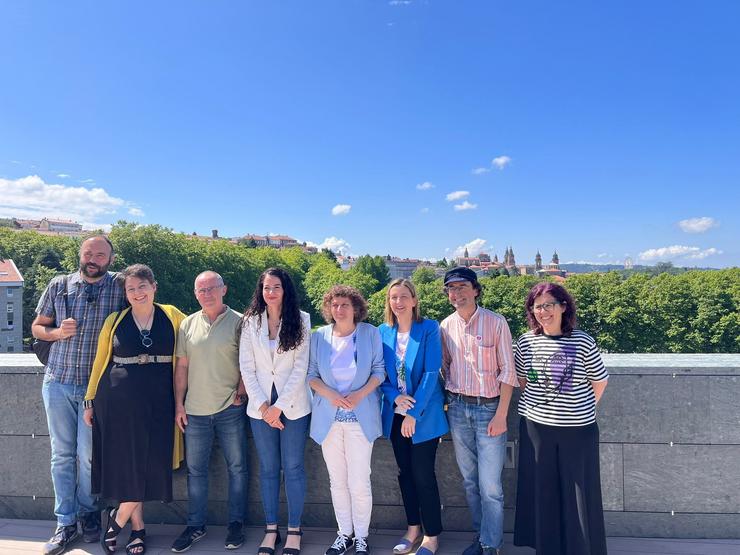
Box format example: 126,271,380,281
514,417,606,555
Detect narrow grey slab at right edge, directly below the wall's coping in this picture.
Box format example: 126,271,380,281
705,376,740,445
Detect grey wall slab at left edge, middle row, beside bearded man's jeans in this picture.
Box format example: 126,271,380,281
0,436,54,497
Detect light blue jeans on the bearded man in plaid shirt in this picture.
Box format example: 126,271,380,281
41,376,98,526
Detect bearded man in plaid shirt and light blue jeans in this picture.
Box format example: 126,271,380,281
31,235,126,555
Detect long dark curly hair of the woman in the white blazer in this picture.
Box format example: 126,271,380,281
244,268,305,352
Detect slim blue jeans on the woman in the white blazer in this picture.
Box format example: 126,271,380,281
249,414,311,528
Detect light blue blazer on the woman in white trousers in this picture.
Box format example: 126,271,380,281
307,322,385,444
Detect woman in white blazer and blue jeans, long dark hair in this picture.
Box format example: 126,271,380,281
239,268,311,555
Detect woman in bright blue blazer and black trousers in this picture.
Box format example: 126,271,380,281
380,279,448,555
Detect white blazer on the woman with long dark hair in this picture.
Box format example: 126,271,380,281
239,311,311,420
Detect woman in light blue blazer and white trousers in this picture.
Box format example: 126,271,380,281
308,285,385,555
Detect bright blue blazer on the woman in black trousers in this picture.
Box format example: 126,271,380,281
380,320,449,443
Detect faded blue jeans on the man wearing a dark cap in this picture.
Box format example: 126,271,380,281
447,399,506,548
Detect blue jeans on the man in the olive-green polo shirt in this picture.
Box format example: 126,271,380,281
185,405,247,526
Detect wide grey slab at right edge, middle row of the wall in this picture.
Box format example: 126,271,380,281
624,445,740,513
